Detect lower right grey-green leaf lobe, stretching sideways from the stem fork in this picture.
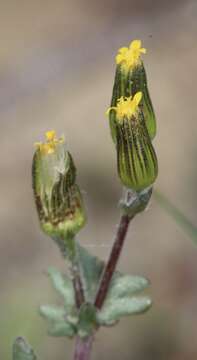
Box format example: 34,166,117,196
97,297,152,325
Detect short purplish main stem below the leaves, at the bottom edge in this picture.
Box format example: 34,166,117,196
74,336,94,360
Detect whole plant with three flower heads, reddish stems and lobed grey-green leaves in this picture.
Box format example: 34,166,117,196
13,40,158,360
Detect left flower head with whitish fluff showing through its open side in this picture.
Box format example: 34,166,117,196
32,131,85,239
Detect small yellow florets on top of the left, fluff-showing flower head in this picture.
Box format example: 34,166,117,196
35,130,64,155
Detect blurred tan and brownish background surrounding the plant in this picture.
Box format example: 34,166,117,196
0,0,197,360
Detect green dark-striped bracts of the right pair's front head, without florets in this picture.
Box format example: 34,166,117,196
116,111,158,191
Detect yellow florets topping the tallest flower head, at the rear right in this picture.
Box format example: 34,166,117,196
116,40,146,70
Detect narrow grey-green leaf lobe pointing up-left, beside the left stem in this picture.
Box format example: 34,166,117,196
48,267,75,308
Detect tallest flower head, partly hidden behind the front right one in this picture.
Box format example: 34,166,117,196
110,40,156,140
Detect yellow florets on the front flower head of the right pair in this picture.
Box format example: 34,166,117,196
106,91,142,121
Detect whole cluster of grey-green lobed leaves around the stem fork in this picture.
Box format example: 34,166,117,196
40,248,151,337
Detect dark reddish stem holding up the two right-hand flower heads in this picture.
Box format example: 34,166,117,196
94,215,134,309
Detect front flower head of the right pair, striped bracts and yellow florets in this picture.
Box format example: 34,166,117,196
107,92,158,191
